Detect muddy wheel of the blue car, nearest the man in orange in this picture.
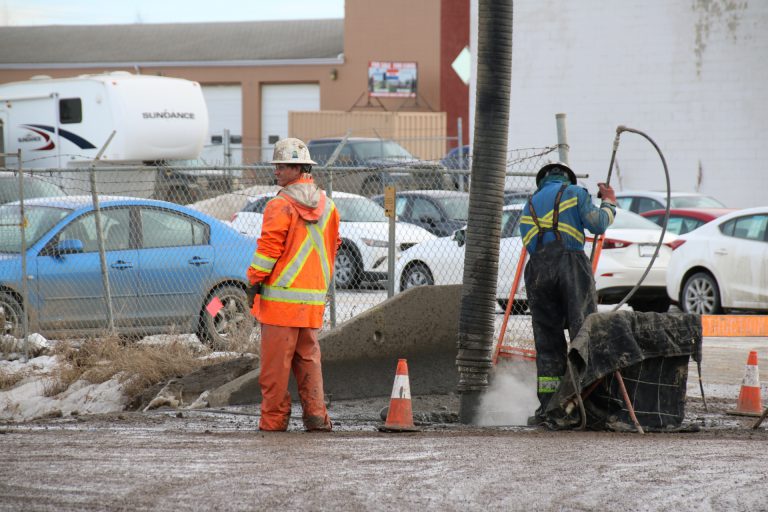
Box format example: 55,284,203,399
198,285,254,350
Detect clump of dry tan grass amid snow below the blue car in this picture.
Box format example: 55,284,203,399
45,338,220,397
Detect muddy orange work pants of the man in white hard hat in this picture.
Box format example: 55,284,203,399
259,324,331,430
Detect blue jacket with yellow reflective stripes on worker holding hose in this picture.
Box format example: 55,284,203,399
520,176,616,254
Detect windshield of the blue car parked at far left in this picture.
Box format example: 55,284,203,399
0,204,72,253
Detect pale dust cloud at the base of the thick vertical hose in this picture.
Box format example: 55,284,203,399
476,362,539,426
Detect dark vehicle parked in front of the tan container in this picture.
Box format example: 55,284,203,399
307,137,455,196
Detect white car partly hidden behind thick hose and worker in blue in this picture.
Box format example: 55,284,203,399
395,205,677,311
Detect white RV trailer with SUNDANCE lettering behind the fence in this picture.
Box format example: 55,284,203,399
0,71,208,199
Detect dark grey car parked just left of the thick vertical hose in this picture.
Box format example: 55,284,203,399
371,190,469,236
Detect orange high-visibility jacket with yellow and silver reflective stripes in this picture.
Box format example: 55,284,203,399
247,175,341,328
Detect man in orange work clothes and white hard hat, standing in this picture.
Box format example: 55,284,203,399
247,138,341,432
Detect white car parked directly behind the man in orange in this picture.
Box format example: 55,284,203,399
230,192,435,288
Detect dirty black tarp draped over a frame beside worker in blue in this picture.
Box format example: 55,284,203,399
546,311,702,431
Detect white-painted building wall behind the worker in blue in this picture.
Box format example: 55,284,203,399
470,0,768,207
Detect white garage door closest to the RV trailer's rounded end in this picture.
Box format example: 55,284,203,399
201,85,243,165
